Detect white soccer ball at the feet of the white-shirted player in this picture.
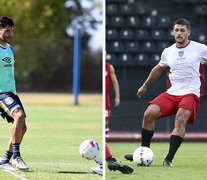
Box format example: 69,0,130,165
133,146,154,166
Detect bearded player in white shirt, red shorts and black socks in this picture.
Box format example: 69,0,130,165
125,18,207,166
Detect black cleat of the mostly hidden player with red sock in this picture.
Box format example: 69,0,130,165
107,161,134,174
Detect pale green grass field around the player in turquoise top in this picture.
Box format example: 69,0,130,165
0,94,102,180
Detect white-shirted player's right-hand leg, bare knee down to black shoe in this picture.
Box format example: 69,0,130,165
163,108,191,166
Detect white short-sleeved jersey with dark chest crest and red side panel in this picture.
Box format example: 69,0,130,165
159,41,207,97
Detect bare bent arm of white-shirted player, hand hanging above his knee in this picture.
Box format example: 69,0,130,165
137,64,166,98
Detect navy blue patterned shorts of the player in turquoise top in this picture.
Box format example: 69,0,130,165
0,92,26,123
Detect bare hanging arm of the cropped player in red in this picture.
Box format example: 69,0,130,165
110,65,120,107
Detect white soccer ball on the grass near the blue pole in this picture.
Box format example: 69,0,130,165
79,139,100,160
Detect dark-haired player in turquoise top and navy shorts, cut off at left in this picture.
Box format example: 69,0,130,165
0,16,29,170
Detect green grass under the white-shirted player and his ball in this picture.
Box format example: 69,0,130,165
106,143,207,180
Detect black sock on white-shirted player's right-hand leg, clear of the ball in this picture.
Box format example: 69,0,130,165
165,135,183,162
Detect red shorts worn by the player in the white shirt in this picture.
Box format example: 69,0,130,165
149,92,200,124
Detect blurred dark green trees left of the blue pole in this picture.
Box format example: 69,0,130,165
0,0,102,91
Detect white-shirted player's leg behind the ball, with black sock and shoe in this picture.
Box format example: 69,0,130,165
124,104,162,161
